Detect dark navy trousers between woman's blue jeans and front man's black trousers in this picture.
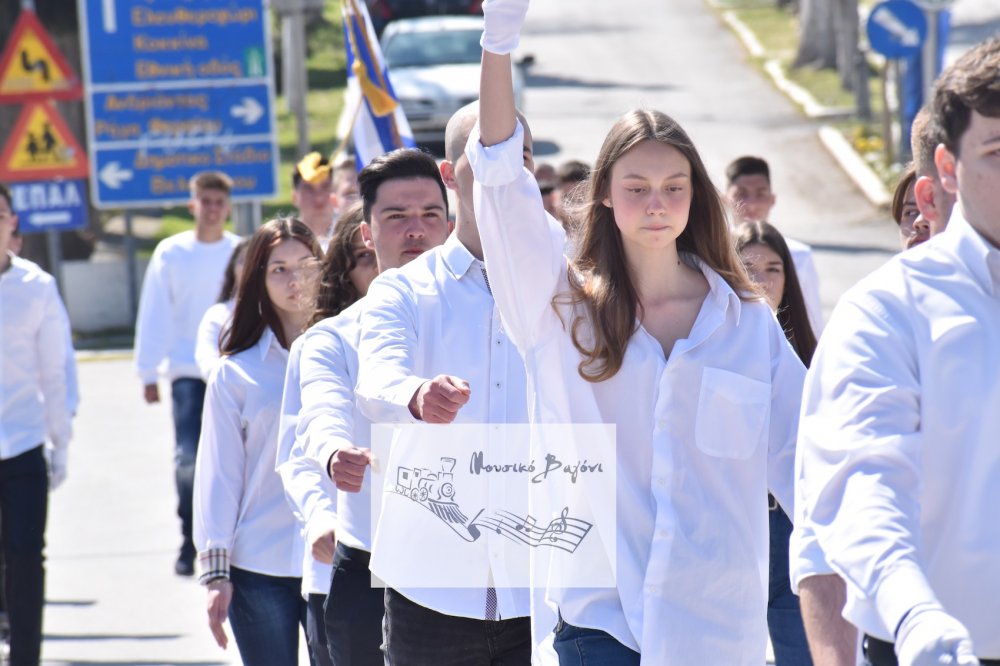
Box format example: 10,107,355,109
323,543,385,666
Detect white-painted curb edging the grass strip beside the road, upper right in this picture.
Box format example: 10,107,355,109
720,0,892,208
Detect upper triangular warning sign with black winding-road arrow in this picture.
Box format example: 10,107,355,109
0,9,83,103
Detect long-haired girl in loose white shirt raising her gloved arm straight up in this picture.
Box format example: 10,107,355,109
466,0,804,665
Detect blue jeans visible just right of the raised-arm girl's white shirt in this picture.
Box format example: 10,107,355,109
767,498,812,666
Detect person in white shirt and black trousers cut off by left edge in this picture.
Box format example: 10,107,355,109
0,185,72,664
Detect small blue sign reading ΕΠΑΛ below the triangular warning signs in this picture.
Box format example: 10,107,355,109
9,180,87,234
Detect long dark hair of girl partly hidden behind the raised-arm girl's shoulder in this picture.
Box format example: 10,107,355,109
735,222,816,368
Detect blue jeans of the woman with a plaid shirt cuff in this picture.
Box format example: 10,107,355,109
229,567,306,666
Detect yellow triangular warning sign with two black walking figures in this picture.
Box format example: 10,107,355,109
0,103,87,182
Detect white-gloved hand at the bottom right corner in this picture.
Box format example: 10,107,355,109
896,604,979,666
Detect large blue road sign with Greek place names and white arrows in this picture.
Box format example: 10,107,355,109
78,0,278,208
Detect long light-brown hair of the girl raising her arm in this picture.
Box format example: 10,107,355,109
570,110,755,382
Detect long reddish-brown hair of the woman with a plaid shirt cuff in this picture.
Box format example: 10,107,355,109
220,217,323,355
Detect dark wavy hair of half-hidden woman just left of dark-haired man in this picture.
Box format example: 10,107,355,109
309,200,365,326
